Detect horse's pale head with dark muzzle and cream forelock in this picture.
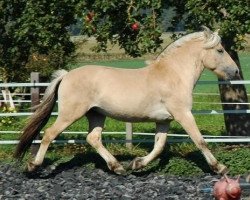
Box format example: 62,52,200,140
202,27,239,80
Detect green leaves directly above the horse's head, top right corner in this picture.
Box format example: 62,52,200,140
172,0,250,50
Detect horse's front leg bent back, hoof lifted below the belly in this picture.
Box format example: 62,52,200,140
129,123,169,170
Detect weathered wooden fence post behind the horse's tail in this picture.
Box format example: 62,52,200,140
30,72,40,156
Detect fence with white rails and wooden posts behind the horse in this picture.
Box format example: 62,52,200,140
0,73,250,148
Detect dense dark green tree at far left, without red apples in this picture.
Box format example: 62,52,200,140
0,0,78,81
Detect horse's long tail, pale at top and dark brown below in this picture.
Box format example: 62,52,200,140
14,70,67,159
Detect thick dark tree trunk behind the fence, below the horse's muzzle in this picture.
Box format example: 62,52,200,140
219,40,250,136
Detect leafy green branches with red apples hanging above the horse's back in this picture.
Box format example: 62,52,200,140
78,0,163,57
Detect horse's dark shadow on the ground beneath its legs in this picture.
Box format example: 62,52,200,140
25,145,213,179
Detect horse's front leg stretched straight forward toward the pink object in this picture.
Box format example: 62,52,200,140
174,111,228,174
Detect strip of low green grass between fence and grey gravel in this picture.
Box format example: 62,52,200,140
0,140,250,176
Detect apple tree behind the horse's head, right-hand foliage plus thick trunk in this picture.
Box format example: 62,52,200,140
171,0,250,136
